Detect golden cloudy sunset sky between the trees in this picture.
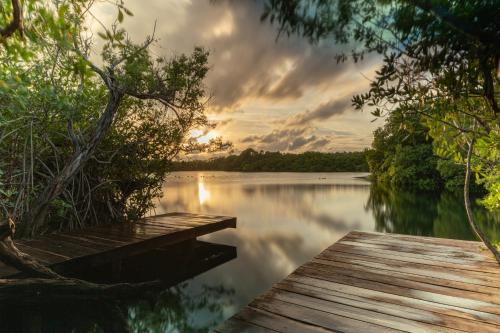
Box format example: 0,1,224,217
95,0,382,152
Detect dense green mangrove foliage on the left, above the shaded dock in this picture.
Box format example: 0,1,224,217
0,0,224,232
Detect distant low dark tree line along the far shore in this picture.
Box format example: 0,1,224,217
172,148,368,172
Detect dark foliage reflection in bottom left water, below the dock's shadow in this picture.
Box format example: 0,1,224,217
0,285,234,333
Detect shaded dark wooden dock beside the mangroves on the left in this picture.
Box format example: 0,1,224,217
0,213,236,277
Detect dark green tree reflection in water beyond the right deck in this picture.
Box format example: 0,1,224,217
365,184,500,241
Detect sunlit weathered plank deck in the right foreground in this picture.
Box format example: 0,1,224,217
214,232,500,333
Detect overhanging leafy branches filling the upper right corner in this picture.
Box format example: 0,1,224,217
262,0,500,209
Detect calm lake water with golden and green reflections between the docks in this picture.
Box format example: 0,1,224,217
4,172,500,332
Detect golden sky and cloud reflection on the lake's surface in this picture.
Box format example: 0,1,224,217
156,172,373,315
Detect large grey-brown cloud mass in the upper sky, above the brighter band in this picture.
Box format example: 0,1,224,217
104,0,364,110
